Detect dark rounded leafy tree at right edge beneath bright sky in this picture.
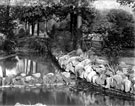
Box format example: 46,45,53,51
107,9,135,47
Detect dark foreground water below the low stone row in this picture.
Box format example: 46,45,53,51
0,87,135,106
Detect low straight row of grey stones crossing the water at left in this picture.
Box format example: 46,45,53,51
0,72,73,87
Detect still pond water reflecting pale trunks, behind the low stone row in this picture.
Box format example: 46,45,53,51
0,56,55,77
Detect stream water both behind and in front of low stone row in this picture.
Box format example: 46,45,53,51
0,55,135,106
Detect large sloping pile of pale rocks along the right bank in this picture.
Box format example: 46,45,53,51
57,52,135,94
